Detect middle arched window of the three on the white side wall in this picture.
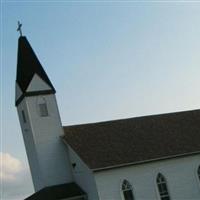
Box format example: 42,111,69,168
156,173,170,200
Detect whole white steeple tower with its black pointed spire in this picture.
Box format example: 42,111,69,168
15,36,72,191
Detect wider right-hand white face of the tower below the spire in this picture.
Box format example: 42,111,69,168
23,95,73,191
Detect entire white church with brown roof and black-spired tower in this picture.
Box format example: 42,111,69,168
15,32,200,200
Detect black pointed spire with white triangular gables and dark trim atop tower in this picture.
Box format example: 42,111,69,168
16,36,56,105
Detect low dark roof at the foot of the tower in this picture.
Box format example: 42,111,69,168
25,183,86,200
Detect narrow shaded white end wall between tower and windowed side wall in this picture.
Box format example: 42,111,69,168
69,147,99,200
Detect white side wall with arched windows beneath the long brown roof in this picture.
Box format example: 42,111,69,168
95,155,200,200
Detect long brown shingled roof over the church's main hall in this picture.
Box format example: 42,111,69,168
64,110,200,170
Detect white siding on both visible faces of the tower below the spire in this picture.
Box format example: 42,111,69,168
18,95,73,191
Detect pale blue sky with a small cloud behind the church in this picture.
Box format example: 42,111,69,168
1,1,200,200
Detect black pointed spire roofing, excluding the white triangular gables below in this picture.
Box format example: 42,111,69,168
16,36,55,105
